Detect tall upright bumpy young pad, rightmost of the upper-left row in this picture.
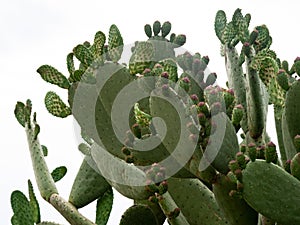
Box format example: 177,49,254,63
108,24,123,62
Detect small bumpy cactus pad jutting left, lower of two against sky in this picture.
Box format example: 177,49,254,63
45,91,71,118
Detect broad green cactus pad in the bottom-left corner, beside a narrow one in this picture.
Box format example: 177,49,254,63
10,191,34,225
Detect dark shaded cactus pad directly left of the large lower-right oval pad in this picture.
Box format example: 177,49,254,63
213,175,258,225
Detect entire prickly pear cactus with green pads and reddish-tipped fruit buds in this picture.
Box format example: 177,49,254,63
11,9,300,225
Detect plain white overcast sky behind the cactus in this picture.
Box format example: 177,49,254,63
0,0,300,225
